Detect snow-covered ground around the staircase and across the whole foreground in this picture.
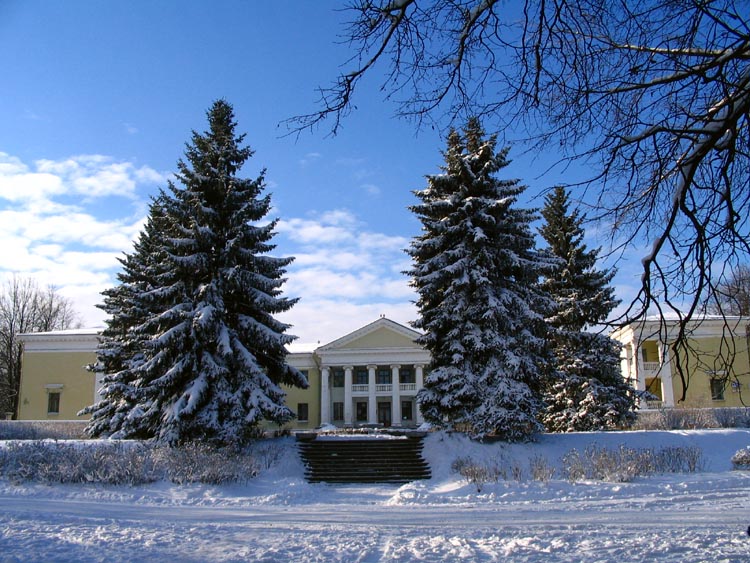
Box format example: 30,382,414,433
0,430,750,563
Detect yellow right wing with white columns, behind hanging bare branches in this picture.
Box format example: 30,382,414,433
610,317,750,409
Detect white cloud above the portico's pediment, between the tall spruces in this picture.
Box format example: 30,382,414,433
279,209,416,344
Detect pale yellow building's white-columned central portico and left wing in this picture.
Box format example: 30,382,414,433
18,318,430,429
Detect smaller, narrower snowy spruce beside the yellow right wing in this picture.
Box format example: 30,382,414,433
539,186,635,432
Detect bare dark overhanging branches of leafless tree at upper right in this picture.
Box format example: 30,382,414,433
287,0,750,398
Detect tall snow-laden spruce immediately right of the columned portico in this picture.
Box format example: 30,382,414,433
407,119,552,441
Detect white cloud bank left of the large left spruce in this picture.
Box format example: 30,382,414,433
0,153,166,325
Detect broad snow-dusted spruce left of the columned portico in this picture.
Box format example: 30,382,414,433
88,100,307,445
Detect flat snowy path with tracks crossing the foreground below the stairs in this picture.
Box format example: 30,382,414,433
0,483,750,563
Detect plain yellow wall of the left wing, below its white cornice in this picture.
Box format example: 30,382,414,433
18,351,96,420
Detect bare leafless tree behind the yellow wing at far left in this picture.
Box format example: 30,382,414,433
0,276,80,413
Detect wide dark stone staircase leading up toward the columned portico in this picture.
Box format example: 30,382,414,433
297,433,431,483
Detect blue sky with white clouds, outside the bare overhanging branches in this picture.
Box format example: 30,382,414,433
0,0,648,348
